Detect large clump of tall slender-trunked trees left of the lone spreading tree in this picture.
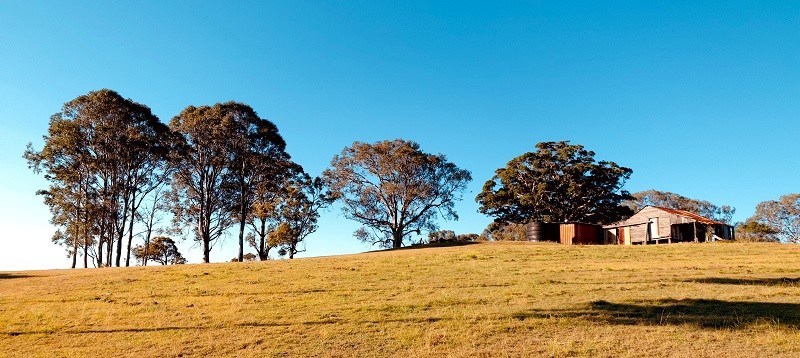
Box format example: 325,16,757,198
24,89,332,267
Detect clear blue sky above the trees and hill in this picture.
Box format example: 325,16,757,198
0,1,800,270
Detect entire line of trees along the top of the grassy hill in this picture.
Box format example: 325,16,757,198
24,89,800,268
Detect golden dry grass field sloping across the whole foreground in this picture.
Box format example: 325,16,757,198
0,243,800,357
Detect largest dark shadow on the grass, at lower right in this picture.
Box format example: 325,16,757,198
512,299,800,329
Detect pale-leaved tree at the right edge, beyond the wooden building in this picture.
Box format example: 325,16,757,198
747,194,800,243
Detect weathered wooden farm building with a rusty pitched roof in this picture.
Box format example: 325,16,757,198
603,206,733,245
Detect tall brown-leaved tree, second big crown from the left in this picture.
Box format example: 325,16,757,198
170,102,288,263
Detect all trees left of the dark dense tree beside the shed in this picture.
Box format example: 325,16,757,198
24,89,471,268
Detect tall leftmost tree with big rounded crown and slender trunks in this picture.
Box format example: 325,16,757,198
25,89,169,266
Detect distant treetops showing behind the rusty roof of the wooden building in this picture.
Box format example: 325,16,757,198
625,189,736,223
